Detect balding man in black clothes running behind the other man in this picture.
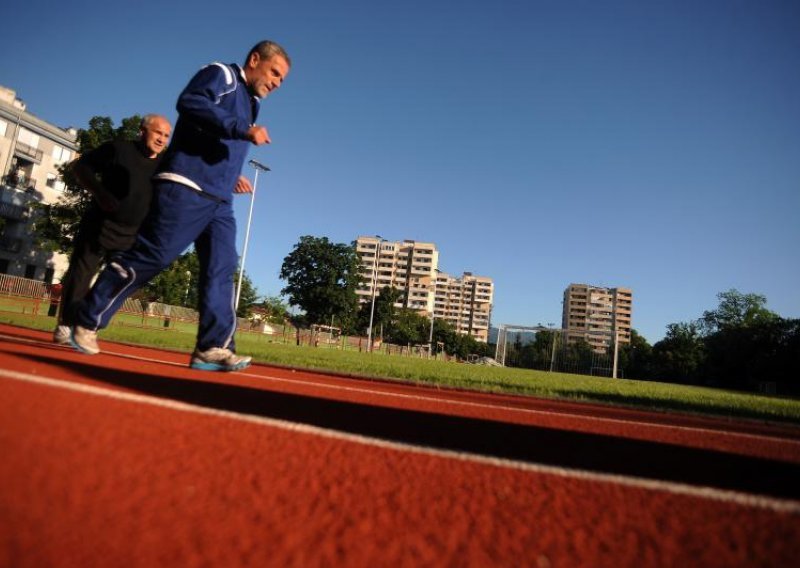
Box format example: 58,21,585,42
53,114,172,345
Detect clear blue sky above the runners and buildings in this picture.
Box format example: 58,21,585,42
0,0,800,343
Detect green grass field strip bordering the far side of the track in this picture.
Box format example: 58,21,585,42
0,312,800,425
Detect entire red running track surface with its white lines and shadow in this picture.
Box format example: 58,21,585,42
0,325,800,568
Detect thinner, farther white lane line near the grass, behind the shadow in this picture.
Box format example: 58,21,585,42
0,334,800,451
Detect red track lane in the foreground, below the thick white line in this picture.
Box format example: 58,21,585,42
0,366,800,567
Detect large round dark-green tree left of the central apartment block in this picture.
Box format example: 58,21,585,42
280,235,361,327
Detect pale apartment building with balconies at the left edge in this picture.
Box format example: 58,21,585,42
0,86,78,282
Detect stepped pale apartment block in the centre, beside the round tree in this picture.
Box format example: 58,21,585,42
356,237,494,342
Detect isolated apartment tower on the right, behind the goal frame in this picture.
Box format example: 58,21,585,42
561,284,633,352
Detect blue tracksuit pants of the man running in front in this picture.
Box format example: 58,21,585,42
77,181,238,351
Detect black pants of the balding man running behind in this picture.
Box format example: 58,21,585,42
58,222,136,326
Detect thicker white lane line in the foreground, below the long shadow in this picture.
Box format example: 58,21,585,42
0,370,800,515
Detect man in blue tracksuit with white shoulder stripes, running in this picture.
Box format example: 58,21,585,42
72,41,291,371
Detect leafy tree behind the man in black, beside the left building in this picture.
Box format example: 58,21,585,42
33,115,142,255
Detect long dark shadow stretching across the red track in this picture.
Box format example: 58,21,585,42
17,356,800,499
